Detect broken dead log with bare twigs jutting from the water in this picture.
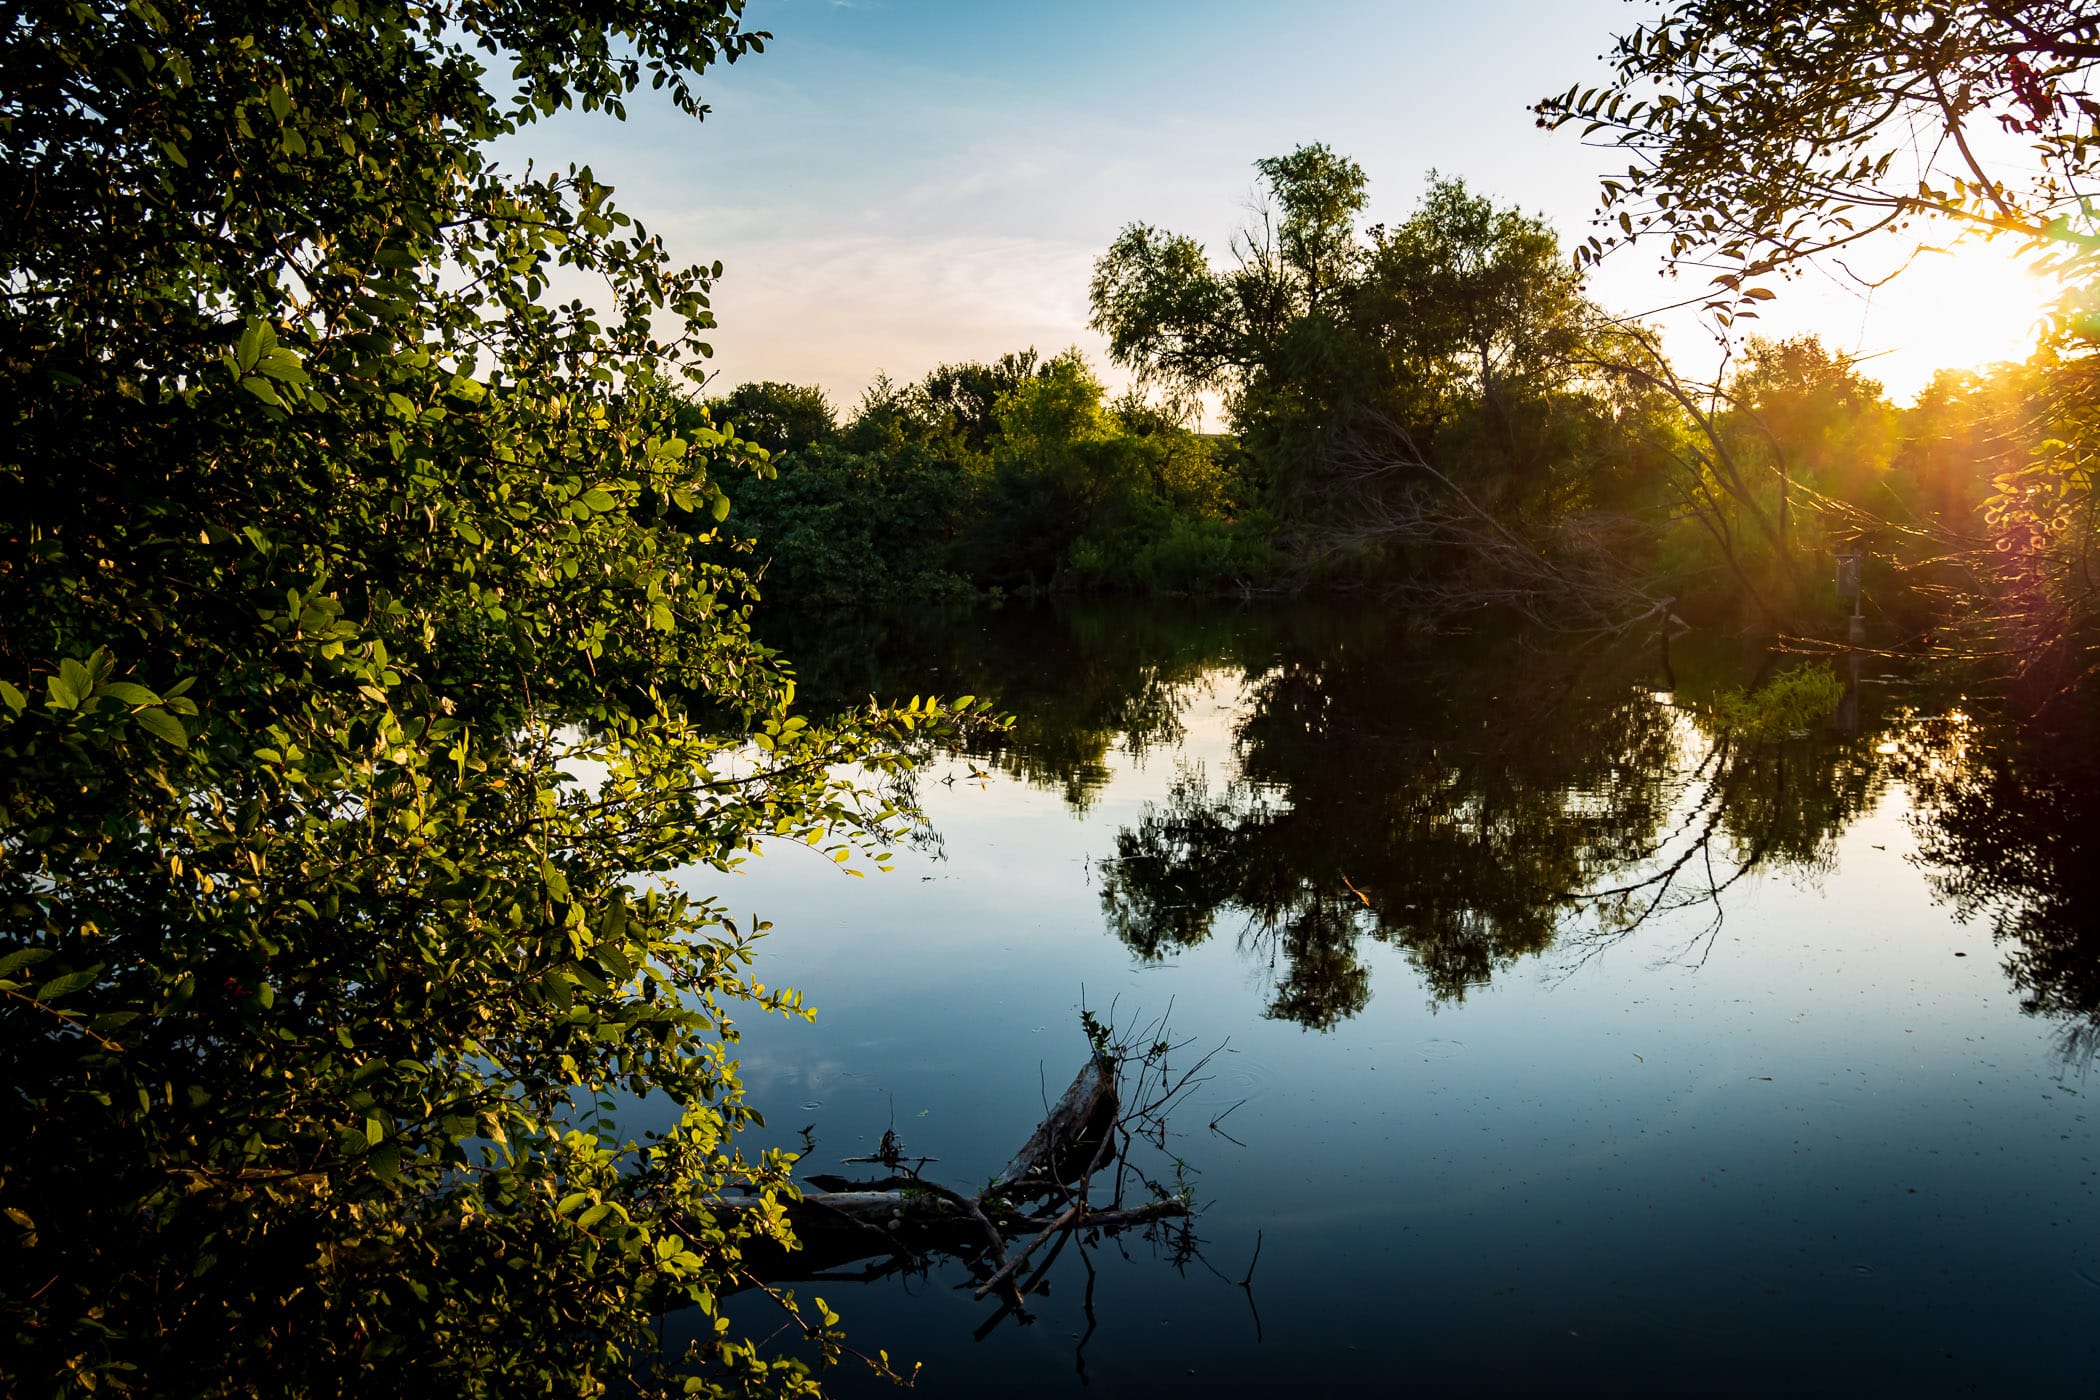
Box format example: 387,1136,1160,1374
722,1026,1210,1329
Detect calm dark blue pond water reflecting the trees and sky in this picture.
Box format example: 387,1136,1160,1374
680,609,2100,1396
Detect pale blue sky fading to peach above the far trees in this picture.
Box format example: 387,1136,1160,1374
516,0,2043,407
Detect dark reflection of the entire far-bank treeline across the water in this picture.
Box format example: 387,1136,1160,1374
769,607,2100,1041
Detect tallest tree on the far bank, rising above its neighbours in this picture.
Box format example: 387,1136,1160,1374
1092,147,1653,615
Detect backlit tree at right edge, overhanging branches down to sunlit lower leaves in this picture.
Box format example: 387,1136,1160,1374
1537,0,2100,655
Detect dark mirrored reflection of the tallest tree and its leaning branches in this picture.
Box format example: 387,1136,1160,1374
1103,630,1886,1028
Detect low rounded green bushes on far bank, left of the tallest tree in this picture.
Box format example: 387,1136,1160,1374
720,351,1268,607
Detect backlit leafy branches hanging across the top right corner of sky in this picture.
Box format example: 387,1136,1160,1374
1537,0,2100,315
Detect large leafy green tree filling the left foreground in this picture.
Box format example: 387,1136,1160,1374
0,0,965,1394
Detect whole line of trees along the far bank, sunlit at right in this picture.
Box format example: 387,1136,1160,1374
713,145,2090,659
